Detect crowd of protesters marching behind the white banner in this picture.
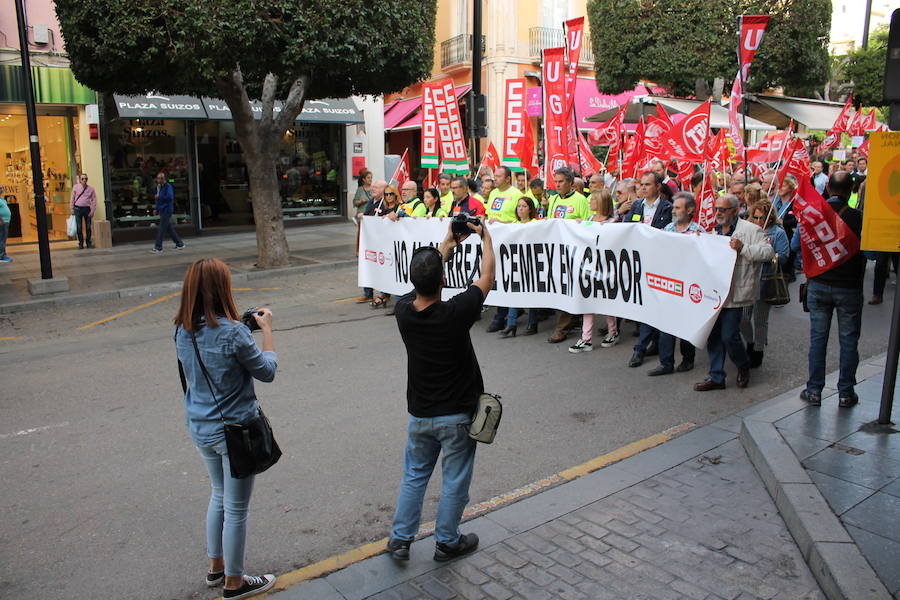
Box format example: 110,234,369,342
354,153,884,406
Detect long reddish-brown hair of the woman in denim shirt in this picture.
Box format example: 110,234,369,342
173,258,239,331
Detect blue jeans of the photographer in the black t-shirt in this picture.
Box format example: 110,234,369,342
391,414,477,544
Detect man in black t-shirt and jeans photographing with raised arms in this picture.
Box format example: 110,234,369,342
387,223,494,561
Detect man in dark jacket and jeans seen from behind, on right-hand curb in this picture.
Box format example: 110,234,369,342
800,171,866,407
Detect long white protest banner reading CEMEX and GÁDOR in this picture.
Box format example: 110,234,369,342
359,217,737,348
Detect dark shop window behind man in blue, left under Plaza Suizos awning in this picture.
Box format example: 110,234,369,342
108,119,191,227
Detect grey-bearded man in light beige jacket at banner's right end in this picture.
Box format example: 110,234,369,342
694,194,775,392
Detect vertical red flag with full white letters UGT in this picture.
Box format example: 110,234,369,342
543,48,571,189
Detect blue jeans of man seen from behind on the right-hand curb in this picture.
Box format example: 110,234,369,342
806,281,863,394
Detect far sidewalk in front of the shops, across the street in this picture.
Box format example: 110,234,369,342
0,222,356,314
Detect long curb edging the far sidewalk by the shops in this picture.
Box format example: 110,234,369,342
0,259,358,315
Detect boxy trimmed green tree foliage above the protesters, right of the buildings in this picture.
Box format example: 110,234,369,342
588,0,831,95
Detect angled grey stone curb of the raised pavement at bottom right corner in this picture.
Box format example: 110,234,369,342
740,388,891,600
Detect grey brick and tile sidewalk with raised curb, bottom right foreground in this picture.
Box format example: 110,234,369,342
272,356,900,600
